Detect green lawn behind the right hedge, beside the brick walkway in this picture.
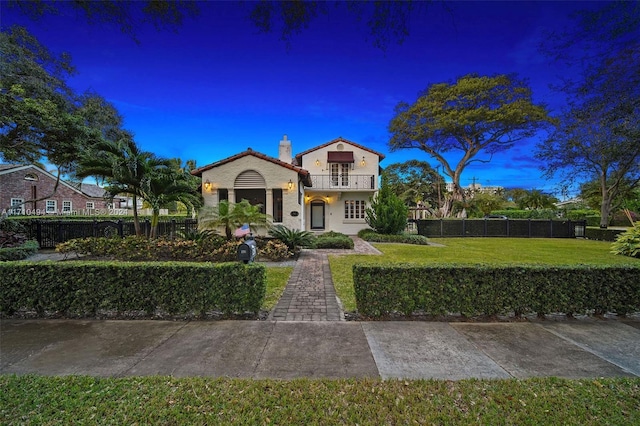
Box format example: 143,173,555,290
329,238,640,312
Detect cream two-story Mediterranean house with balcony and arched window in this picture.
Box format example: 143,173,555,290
192,135,384,235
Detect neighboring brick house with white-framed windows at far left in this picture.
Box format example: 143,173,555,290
0,164,111,215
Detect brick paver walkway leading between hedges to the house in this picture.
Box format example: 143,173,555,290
269,238,380,321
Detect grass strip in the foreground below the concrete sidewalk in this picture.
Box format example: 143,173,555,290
0,375,640,425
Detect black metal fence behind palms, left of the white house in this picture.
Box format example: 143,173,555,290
22,219,198,248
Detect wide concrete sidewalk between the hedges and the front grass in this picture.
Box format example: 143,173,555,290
0,318,640,380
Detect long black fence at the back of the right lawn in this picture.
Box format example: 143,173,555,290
415,219,586,238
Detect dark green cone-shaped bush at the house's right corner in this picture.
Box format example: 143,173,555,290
365,178,409,234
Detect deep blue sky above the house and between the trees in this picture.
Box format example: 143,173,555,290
1,2,601,197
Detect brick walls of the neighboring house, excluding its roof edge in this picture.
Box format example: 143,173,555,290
0,165,108,215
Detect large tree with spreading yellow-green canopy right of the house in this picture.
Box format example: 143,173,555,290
389,74,549,216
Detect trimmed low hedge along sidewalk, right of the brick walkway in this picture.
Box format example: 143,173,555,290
353,265,640,317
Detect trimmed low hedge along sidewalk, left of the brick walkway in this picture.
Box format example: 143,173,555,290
0,262,266,317
